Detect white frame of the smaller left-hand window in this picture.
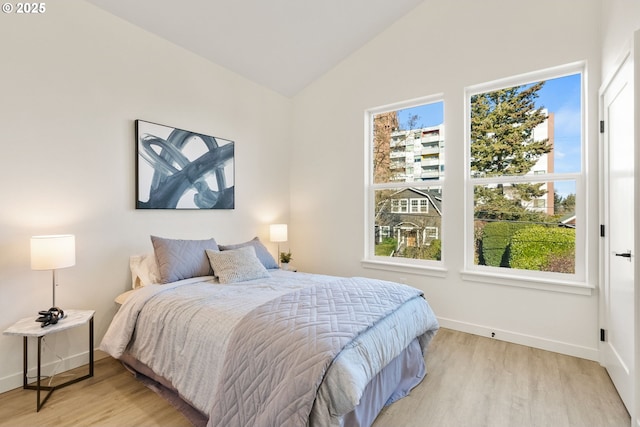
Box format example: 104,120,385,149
361,93,447,277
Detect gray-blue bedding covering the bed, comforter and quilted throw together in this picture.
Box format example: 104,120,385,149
100,270,438,427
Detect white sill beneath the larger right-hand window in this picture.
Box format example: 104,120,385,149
460,270,594,296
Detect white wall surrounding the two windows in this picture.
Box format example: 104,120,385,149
290,0,600,359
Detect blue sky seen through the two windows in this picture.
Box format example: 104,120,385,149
398,74,582,196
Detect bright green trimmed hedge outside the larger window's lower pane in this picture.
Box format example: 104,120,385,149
509,225,576,273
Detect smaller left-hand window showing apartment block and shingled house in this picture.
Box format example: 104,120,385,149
366,97,445,265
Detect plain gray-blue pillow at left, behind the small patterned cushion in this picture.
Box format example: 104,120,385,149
151,236,218,283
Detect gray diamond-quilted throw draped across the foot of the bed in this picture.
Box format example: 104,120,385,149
209,278,422,427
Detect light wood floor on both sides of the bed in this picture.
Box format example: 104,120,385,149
0,329,631,427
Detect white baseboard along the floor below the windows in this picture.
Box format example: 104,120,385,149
438,317,600,362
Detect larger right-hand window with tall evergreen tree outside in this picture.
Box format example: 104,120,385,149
465,65,586,282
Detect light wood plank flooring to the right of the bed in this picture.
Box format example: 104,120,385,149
373,329,631,427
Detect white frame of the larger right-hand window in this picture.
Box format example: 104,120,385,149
462,61,593,294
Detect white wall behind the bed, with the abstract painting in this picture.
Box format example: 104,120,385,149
0,1,291,391
